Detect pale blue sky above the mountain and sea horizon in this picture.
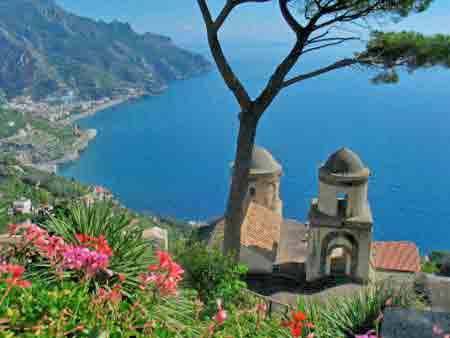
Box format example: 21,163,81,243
56,0,450,44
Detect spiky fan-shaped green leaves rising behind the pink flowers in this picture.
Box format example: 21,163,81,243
43,202,153,290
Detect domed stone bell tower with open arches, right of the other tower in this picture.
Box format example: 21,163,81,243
307,148,373,283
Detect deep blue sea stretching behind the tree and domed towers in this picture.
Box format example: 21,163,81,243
60,44,450,252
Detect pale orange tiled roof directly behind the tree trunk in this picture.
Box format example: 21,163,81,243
209,202,282,251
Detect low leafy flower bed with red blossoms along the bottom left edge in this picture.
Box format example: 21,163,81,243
0,235,300,338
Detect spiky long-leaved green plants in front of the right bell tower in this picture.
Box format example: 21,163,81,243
298,282,423,338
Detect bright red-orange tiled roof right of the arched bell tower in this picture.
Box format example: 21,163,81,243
372,242,420,272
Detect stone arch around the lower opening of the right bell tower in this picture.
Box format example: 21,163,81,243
320,231,359,276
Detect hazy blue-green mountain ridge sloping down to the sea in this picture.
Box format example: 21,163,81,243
0,0,210,98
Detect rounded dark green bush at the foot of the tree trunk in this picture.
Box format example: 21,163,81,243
175,241,247,308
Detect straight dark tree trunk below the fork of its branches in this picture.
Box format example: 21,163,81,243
223,112,258,261
